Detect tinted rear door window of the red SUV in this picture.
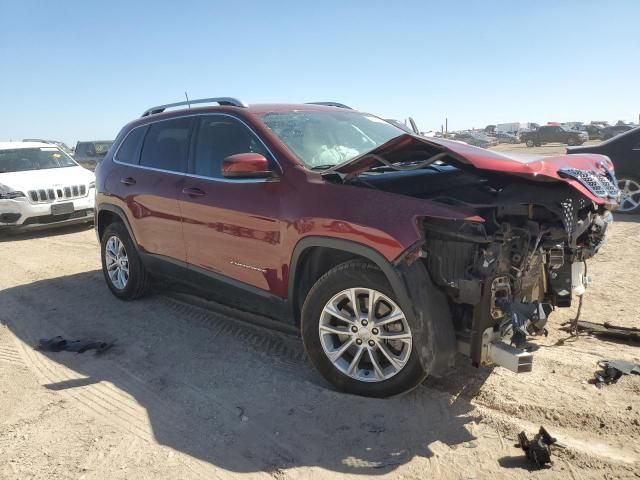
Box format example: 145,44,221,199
140,118,192,172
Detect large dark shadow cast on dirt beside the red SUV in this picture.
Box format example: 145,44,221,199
0,270,489,475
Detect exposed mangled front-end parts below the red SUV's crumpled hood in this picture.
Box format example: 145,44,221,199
421,189,612,372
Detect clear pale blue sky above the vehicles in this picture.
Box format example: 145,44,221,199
0,0,640,143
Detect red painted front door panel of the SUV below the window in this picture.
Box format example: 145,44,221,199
179,178,287,292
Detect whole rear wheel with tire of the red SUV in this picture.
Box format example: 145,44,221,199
100,222,150,300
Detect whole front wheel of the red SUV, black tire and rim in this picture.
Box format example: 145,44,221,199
301,261,428,397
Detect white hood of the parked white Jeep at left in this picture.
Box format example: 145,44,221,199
0,166,96,192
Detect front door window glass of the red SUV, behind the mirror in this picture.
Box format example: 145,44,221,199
193,115,270,178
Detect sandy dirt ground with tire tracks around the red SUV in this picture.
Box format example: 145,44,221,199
0,155,640,480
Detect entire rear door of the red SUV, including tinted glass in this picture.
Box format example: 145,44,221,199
114,117,193,262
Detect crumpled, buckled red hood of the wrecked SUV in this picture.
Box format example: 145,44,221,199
324,134,617,204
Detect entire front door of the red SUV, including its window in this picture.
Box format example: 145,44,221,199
180,114,286,291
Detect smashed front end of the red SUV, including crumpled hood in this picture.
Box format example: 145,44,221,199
334,136,620,372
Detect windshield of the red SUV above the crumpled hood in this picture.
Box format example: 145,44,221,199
263,111,405,169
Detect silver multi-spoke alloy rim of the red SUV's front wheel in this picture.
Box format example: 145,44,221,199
318,288,413,382
